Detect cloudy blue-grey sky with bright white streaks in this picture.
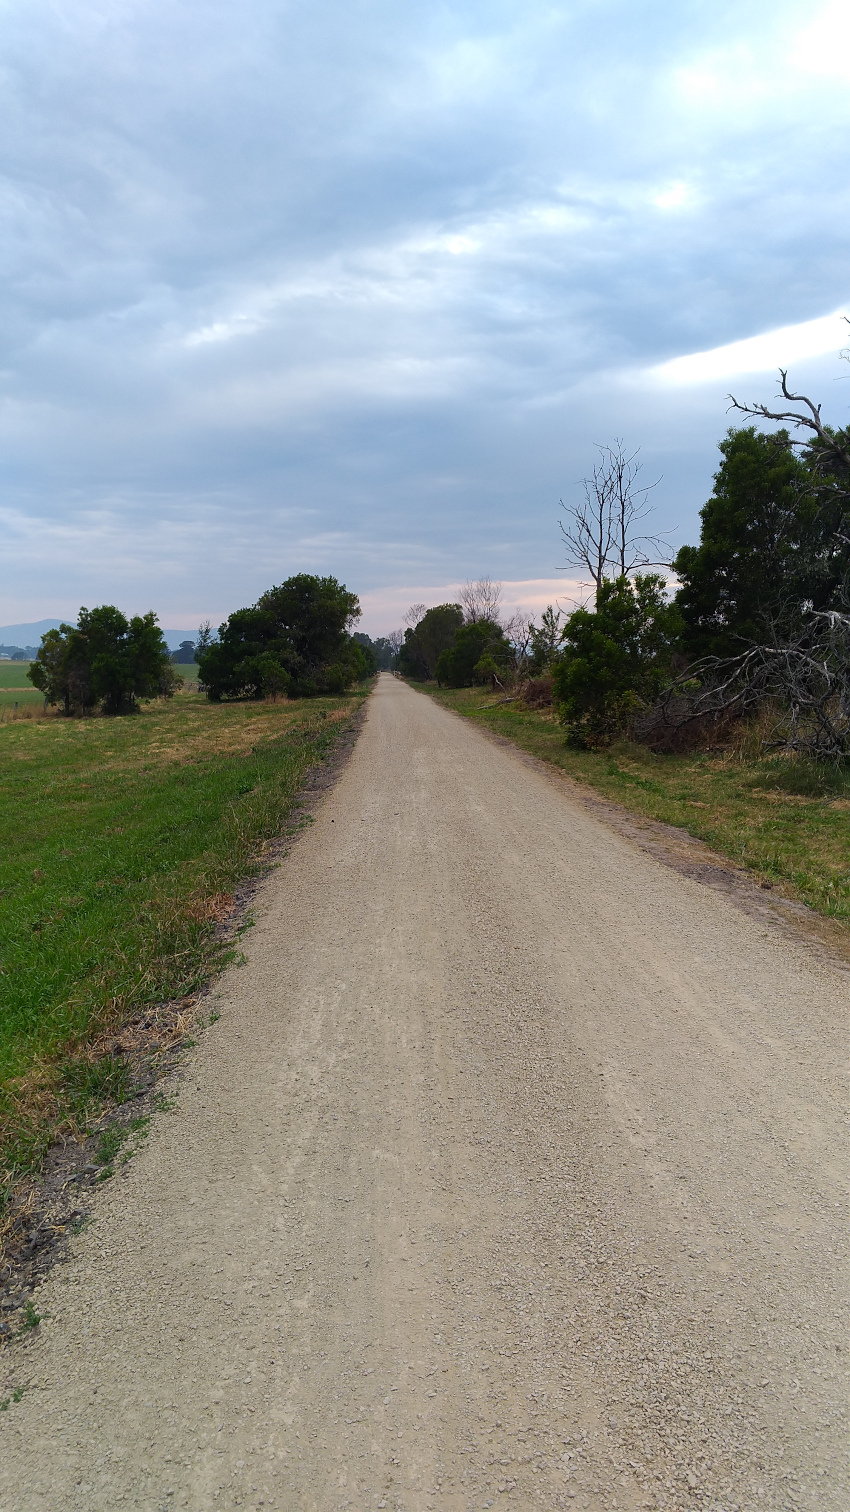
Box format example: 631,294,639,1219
0,0,850,635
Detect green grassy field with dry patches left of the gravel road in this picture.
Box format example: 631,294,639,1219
0,691,363,1202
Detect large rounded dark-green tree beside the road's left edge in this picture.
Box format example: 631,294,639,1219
198,573,369,700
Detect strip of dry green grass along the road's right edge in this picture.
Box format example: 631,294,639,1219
413,683,850,924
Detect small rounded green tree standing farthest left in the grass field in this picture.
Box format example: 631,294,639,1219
29,603,175,714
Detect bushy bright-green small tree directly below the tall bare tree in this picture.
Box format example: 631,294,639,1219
554,573,681,745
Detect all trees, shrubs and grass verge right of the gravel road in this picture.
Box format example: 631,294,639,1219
396,368,850,922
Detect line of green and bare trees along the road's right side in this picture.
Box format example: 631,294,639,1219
398,353,850,761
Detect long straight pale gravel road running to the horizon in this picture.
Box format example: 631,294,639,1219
0,676,850,1512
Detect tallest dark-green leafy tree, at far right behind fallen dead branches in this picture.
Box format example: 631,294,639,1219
673,426,828,656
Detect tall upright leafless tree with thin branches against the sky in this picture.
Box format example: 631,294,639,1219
560,437,669,593
